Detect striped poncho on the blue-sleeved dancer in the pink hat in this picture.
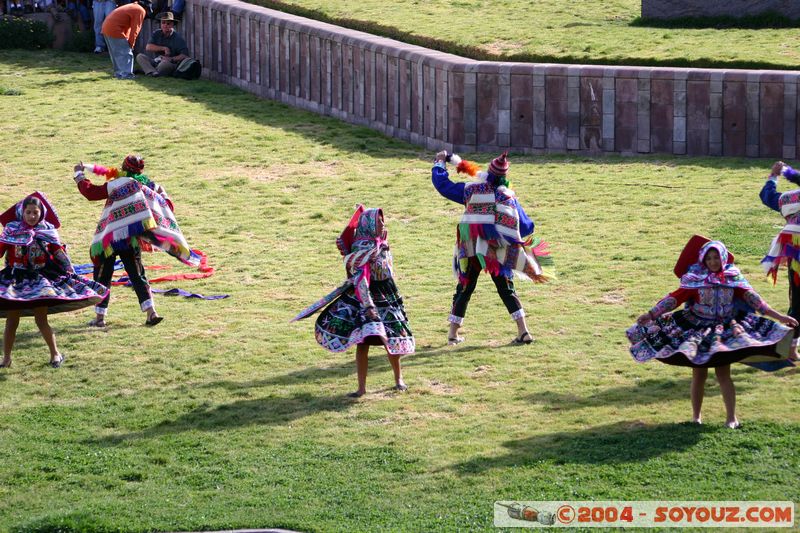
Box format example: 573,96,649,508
453,182,552,283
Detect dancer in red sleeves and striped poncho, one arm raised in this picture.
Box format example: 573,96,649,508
75,155,201,327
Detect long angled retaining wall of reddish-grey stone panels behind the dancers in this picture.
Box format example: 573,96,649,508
182,0,800,159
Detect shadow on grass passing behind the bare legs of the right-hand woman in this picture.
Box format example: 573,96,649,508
524,376,758,411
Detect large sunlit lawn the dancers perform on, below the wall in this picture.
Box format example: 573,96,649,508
0,51,800,532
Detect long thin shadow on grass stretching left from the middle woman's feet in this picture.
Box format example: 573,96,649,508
88,393,357,446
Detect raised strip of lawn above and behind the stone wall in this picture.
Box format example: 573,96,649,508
251,0,800,70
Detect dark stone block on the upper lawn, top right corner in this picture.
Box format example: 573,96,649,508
642,0,800,19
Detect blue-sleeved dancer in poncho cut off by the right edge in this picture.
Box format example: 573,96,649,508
759,161,800,361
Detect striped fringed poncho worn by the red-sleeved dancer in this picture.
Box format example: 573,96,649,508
89,177,201,266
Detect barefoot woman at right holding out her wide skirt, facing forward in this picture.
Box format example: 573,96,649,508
626,235,798,429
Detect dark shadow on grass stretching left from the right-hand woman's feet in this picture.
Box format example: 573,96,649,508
453,421,708,474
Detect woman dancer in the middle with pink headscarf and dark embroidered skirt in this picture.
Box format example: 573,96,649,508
293,205,414,398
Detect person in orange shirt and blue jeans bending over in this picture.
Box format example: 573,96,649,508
101,0,150,80
